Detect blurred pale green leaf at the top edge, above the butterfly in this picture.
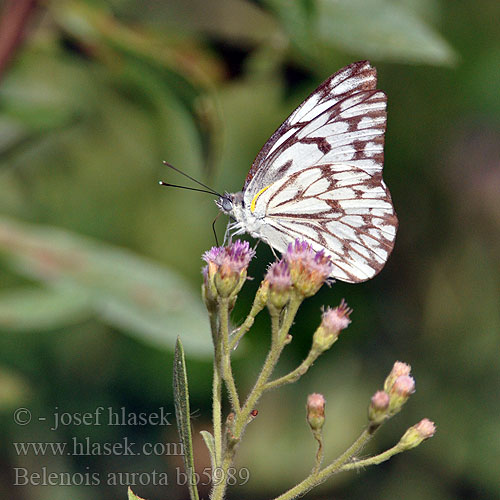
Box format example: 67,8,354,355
317,0,457,65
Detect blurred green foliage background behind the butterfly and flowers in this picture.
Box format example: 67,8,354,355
0,0,500,500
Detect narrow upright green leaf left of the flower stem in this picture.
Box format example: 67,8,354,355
174,338,198,500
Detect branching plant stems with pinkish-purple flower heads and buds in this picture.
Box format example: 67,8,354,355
193,236,436,500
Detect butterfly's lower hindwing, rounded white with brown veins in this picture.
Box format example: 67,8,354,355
255,164,397,283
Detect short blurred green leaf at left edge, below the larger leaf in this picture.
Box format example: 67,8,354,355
0,287,92,331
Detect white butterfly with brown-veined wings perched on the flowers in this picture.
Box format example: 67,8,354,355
216,61,398,283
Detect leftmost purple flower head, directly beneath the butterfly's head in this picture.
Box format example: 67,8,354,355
203,240,255,302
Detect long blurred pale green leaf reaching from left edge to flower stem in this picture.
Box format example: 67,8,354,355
0,218,211,356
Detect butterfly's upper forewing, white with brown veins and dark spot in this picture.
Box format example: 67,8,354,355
243,61,386,193
